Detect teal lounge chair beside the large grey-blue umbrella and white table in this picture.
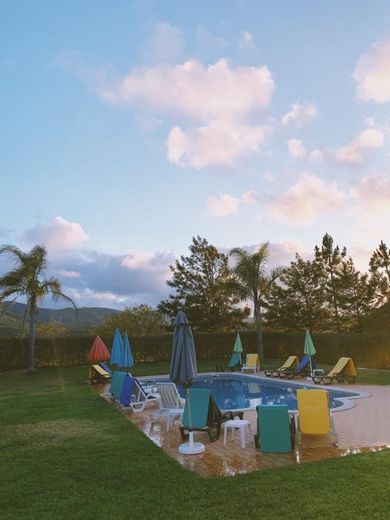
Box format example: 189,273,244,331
180,388,233,442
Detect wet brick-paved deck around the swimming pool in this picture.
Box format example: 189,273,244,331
100,378,390,477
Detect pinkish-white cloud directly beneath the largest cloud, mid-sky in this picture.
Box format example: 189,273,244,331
166,118,270,169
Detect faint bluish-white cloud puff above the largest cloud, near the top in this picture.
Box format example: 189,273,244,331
142,22,185,63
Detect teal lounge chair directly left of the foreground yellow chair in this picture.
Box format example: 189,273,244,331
255,404,295,453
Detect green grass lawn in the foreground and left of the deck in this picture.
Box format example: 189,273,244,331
0,363,390,520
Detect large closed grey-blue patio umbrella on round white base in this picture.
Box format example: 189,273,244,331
169,311,205,455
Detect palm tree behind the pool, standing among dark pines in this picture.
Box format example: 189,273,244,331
229,242,280,360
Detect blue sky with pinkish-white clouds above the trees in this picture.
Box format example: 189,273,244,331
0,0,390,308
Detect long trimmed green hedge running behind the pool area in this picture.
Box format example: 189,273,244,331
0,331,390,370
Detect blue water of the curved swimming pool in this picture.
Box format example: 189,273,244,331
148,373,368,411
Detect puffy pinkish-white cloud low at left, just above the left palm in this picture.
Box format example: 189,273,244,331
24,217,89,256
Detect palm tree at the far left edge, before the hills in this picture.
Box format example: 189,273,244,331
0,245,77,374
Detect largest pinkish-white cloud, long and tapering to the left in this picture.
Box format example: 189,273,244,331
101,59,274,123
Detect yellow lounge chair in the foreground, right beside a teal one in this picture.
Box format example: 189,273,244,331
297,389,337,446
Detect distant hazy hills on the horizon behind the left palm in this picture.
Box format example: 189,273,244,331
0,302,120,335
